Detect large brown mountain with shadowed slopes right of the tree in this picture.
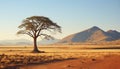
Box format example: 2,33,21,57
59,26,120,43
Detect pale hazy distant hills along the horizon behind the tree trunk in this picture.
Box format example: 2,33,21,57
0,39,59,45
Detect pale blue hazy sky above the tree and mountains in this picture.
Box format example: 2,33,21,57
0,0,120,40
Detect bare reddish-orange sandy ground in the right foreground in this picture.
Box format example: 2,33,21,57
20,55,120,69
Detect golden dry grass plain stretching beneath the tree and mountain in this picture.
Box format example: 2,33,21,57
0,45,120,69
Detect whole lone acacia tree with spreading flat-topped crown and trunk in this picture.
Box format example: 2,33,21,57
17,16,61,52
